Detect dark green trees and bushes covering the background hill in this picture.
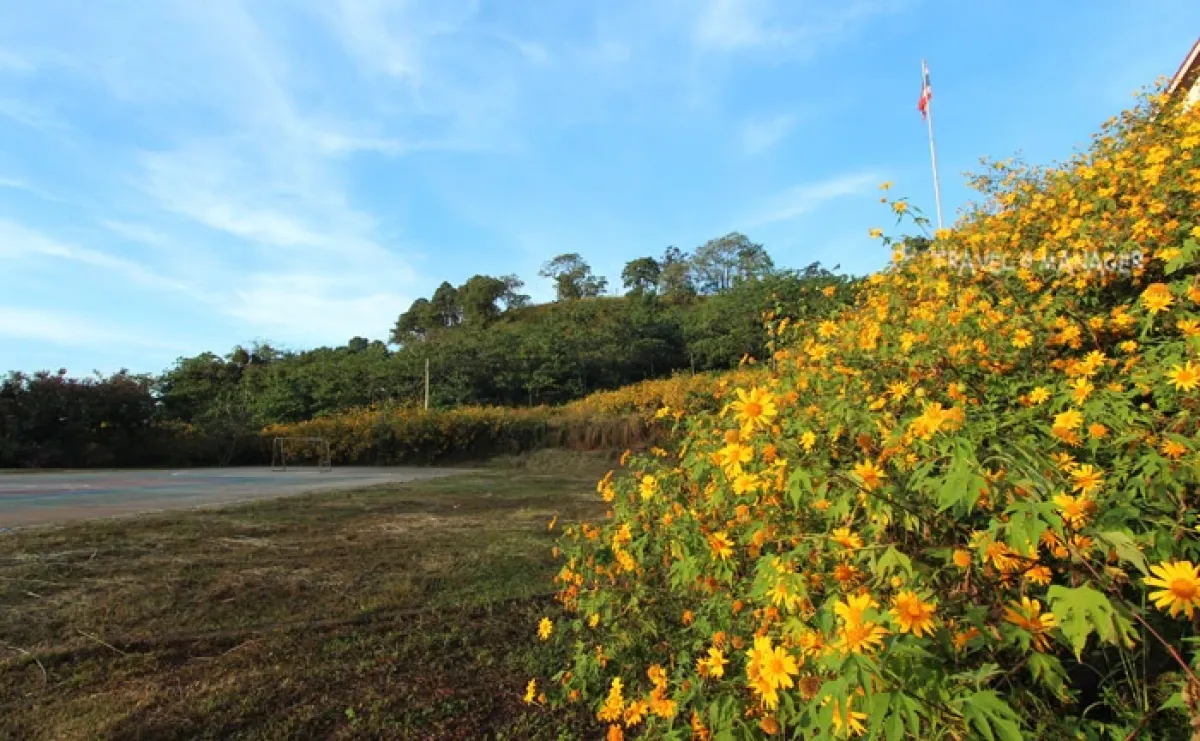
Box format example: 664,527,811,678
0,233,853,466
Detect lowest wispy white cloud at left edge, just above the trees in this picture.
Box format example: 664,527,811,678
0,306,186,353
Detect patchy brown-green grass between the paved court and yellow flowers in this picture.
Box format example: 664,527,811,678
0,462,599,741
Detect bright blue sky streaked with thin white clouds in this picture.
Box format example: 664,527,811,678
0,0,1200,373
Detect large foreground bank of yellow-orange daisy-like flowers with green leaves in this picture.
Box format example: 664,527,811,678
532,89,1200,741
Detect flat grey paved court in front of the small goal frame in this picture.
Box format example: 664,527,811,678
0,468,458,530
